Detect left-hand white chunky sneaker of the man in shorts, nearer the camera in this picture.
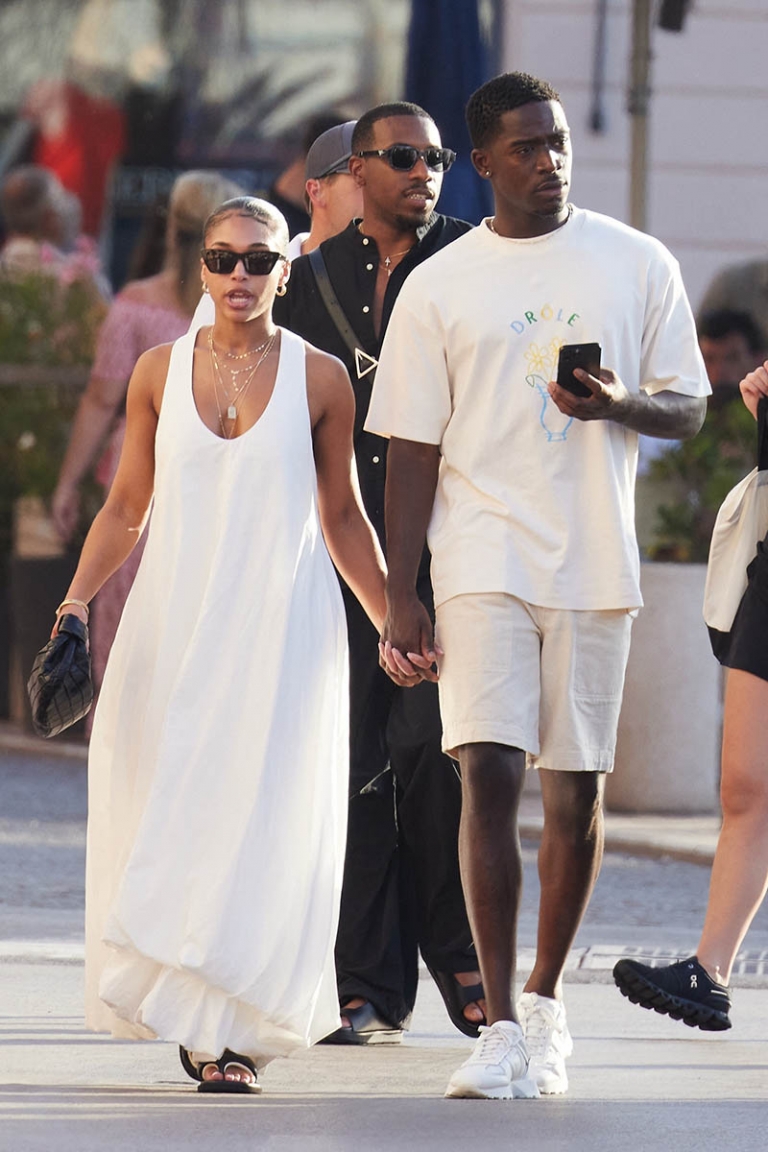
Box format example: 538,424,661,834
446,1020,539,1100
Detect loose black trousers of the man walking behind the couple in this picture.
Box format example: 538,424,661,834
336,590,477,1026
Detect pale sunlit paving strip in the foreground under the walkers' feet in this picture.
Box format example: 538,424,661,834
0,963,768,1152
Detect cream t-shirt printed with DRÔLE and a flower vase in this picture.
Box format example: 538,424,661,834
365,209,709,609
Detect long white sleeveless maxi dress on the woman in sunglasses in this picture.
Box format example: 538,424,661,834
86,329,349,1067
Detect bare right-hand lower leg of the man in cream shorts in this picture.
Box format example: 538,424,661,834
524,770,606,1000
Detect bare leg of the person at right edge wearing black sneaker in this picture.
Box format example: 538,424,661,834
697,669,768,984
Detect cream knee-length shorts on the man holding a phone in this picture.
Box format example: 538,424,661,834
435,592,636,772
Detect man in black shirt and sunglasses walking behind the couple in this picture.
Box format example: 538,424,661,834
274,103,485,1044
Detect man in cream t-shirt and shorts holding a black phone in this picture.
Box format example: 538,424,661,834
366,74,709,1098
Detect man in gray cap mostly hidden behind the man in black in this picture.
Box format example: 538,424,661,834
288,120,363,260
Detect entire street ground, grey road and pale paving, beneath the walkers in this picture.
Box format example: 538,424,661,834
0,727,768,1152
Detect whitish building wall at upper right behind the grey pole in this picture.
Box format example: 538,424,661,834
502,0,768,308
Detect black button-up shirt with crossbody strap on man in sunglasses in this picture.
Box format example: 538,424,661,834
273,213,472,544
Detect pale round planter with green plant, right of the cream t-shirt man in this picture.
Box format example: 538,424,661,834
606,399,755,813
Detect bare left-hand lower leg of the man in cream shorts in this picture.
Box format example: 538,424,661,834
458,743,525,1024
